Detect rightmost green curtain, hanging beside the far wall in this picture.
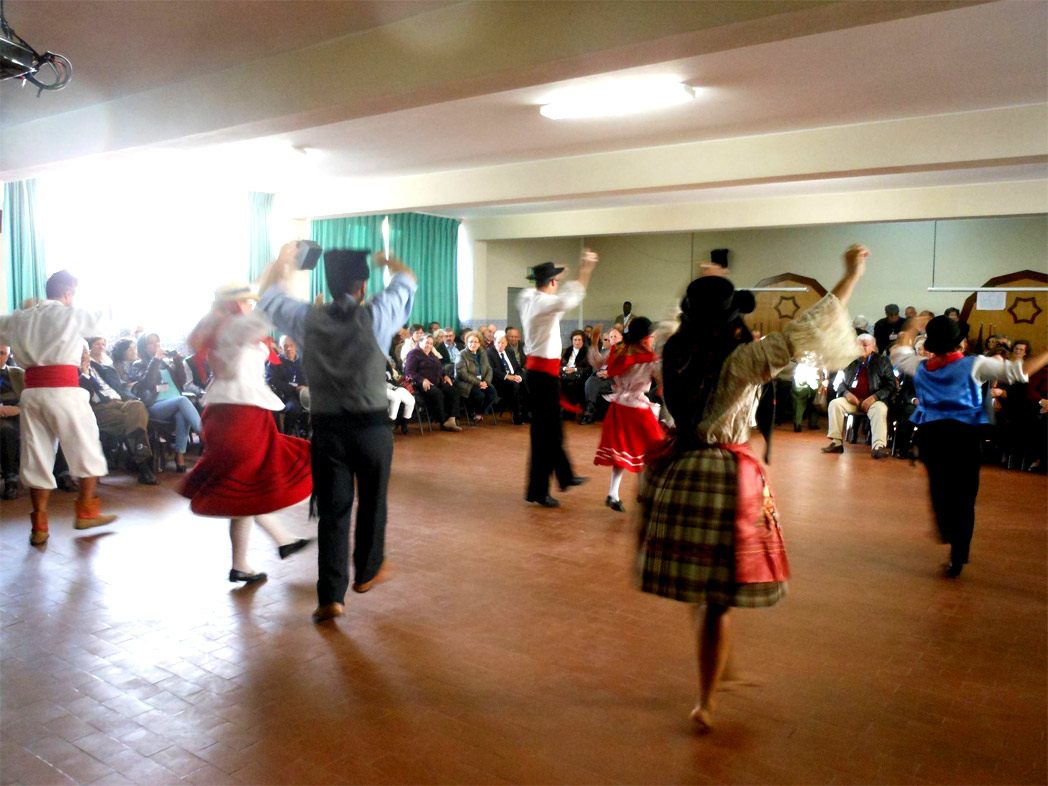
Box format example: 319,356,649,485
390,213,461,330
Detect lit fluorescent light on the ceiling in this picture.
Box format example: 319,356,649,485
539,77,696,121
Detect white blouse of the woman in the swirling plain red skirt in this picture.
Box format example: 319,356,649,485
203,312,284,412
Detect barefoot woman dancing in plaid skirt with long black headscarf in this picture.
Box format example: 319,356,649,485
637,245,869,732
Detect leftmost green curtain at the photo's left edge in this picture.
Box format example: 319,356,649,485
3,180,47,311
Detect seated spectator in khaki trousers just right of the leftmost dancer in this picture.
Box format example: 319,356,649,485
80,340,159,486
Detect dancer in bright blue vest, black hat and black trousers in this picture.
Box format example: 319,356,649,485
892,316,1048,578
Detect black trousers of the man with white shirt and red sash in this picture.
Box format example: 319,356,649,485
524,369,575,500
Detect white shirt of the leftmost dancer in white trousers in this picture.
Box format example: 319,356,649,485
0,300,102,368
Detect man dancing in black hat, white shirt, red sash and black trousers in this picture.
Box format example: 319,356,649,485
517,248,597,507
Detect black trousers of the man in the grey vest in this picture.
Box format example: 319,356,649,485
311,410,393,605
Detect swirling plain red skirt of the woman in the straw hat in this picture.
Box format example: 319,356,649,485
180,403,313,518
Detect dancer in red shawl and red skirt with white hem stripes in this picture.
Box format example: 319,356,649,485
589,316,663,514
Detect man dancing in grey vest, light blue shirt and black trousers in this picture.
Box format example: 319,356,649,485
259,242,418,623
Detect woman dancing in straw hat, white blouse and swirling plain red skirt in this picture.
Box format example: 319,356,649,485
181,284,313,583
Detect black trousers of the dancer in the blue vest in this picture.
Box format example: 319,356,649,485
917,420,982,565
